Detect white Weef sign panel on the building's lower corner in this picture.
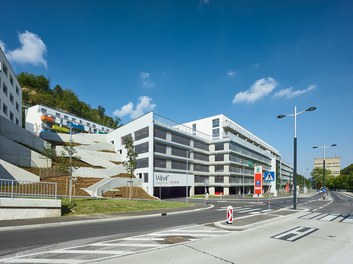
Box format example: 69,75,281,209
153,172,194,187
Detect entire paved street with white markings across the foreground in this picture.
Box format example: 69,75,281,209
0,192,353,263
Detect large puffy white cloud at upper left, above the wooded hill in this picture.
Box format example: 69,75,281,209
6,30,48,68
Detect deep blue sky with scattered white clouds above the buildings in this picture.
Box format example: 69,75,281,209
0,0,353,176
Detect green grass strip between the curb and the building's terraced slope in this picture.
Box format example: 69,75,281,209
61,199,194,216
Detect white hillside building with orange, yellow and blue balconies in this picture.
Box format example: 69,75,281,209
25,105,113,135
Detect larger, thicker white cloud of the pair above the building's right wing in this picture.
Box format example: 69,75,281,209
233,77,278,104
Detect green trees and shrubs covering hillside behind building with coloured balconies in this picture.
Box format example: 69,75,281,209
17,72,120,128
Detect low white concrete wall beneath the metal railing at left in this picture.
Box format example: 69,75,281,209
0,198,61,220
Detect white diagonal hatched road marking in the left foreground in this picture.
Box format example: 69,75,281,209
0,225,230,264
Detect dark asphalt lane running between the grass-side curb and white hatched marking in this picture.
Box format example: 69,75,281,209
0,192,340,258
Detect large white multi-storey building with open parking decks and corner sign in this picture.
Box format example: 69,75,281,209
107,112,281,198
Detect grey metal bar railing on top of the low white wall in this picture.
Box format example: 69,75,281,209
0,179,58,199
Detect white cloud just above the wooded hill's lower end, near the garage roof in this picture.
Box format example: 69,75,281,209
113,96,157,119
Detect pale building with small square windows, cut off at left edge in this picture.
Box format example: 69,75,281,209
0,48,22,126
